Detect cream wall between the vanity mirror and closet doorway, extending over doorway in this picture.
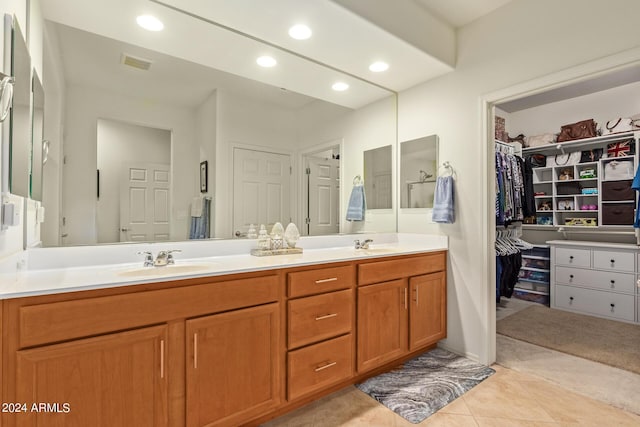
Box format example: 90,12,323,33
398,0,640,362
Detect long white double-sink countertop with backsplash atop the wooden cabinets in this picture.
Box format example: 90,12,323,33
0,233,448,299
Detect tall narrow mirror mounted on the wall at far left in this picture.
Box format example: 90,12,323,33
8,18,31,197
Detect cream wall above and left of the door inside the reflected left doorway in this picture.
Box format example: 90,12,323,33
96,119,171,243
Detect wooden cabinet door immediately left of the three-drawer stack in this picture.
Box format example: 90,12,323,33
186,303,282,427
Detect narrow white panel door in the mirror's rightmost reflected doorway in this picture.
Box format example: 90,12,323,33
307,157,340,236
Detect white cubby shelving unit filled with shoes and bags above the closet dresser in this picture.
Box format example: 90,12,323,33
523,132,640,228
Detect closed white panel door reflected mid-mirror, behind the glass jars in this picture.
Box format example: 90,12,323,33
233,148,291,237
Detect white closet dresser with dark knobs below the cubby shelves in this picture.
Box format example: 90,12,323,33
547,240,640,323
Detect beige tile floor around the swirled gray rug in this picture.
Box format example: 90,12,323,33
263,302,640,427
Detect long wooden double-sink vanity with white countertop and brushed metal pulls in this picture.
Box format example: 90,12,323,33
1,233,447,426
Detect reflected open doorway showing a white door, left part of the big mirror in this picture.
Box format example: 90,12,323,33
96,119,171,243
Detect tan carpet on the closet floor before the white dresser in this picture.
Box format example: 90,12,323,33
496,305,640,374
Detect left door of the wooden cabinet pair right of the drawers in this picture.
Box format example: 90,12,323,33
357,279,408,372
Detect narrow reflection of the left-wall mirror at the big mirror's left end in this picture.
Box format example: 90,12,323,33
30,70,45,201
